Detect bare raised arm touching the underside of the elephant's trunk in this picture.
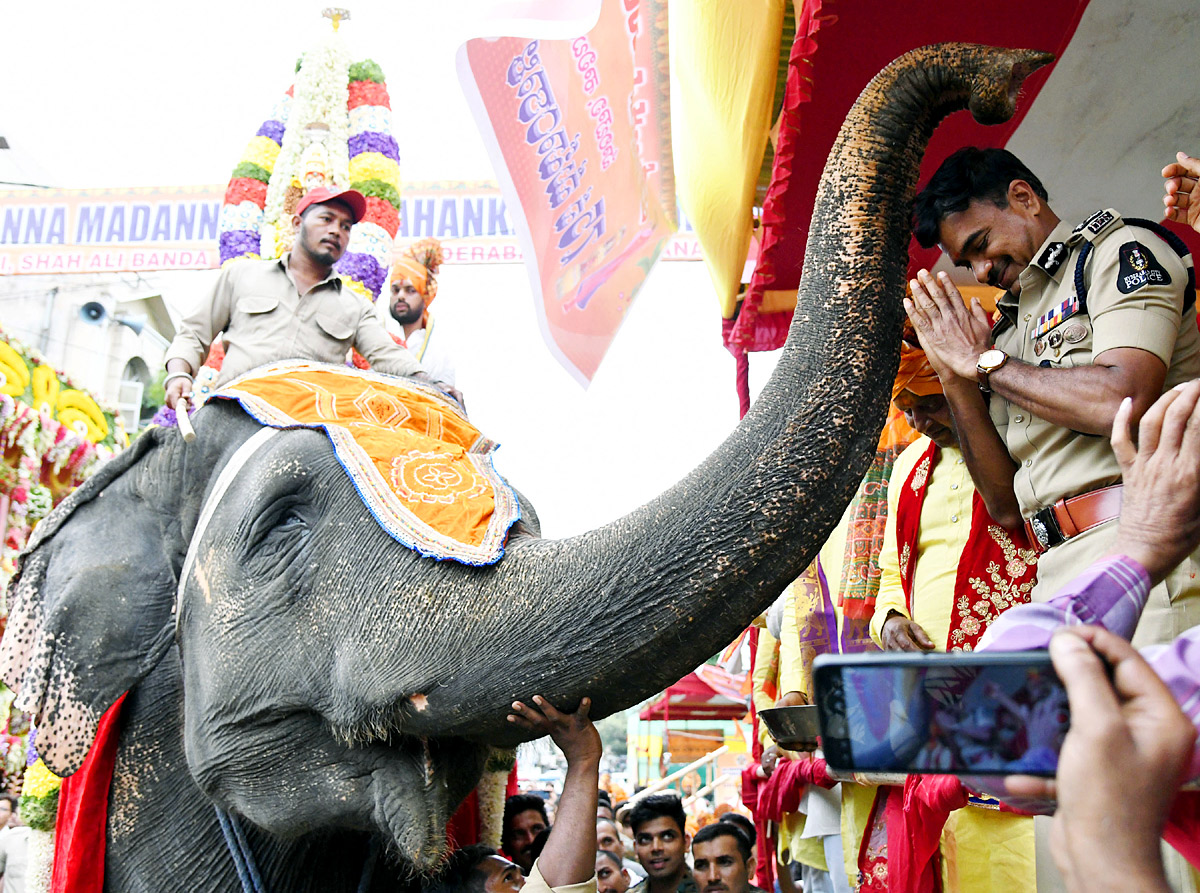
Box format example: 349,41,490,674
509,695,604,887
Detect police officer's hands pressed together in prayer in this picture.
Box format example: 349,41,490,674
904,270,991,383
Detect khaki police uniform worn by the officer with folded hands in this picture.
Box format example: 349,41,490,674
989,209,1200,643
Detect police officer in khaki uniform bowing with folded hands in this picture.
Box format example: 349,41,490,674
905,148,1200,643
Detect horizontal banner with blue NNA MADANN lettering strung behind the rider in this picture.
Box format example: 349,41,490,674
0,181,701,276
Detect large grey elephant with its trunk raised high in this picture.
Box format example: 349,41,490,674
0,44,1050,891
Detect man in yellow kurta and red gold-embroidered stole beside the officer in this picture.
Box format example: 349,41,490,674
871,344,1036,893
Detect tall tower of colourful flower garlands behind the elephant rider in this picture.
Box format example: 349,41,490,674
207,8,400,402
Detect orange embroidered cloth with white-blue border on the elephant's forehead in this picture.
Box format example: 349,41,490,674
212,360,521,565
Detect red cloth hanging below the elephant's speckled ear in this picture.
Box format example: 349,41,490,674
50,695,125,893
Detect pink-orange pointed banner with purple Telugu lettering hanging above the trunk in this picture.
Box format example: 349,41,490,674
458,0,674,386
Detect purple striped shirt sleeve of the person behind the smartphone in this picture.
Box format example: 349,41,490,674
979,556,1200,780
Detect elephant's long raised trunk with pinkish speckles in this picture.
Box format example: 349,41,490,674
379,44,1051,743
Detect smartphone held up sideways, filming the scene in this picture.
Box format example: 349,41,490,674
812,651,1070,775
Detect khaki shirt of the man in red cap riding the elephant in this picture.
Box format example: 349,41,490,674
167,254,424,384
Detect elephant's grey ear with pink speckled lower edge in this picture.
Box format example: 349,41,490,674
0,428,182,774
